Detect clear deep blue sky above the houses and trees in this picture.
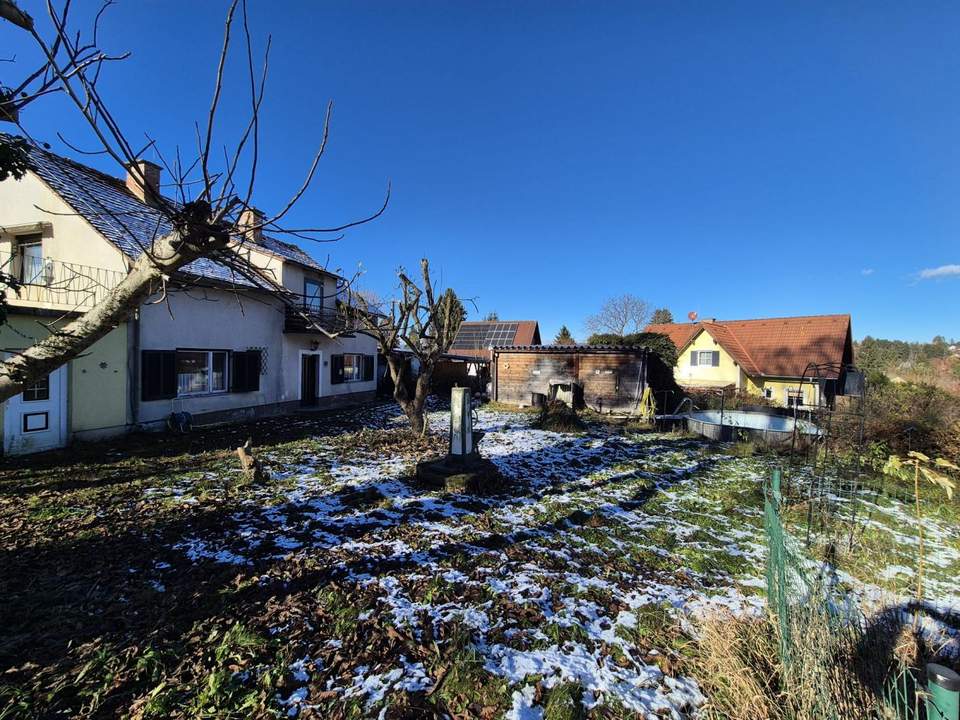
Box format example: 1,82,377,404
0,0,960,340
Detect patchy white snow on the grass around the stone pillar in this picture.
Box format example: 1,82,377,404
156,402,953,719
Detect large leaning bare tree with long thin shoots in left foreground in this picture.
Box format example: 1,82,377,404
0,0,390,401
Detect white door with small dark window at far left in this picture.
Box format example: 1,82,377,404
3,367,67,455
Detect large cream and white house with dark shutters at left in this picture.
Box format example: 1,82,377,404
0,135,377,453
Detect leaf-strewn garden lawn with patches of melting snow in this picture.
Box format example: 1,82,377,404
0,408,960,720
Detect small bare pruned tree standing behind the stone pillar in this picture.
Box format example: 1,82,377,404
349,258,466,435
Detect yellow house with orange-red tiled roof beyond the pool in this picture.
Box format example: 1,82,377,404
646,315,853,407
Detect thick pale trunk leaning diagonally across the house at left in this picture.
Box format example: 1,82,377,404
0,230,228,402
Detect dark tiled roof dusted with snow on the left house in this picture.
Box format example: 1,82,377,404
6,133,327,286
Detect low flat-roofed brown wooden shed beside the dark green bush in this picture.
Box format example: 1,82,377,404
492,345,672,414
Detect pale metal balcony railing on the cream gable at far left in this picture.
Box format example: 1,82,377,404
0,251,126,311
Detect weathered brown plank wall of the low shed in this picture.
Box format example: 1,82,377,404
496,352,647,412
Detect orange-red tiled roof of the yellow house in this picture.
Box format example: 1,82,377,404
646,315,853,377
